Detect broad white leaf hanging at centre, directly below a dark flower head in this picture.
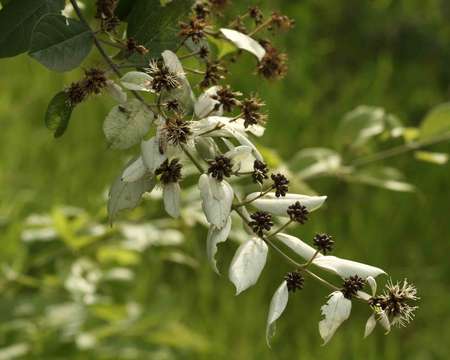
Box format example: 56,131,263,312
198,174,234,229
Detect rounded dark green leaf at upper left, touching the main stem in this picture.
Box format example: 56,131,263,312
29,14,94,72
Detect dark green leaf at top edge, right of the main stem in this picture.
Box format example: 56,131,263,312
127,0,193,63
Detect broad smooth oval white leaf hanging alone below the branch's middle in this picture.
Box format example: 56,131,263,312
228,237,269,295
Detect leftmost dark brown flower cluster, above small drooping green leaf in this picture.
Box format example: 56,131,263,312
66,68,108,106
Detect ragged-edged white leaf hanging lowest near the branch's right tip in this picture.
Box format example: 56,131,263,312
319,291,352,345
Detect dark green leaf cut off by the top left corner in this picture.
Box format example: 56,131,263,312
0,0,64,58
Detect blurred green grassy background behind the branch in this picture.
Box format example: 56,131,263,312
0,0,450,360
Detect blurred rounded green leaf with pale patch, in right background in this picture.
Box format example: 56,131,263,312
337,106,386,148
